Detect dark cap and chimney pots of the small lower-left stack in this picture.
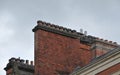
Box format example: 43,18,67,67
4,57,34,72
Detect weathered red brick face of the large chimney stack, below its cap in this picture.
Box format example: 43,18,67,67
35,30,91,75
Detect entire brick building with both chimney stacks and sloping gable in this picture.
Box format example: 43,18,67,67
5,21,120,75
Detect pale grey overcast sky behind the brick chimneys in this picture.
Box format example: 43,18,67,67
0,0,120,75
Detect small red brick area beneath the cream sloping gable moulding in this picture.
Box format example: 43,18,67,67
97,63,120,75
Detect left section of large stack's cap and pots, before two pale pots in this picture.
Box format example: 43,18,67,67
33,21,83,38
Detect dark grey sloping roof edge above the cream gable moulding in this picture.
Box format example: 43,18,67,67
70,46,120,75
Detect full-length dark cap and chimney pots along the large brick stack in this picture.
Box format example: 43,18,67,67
32,20,118,46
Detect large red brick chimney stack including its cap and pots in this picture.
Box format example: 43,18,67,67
33,21,119,75
